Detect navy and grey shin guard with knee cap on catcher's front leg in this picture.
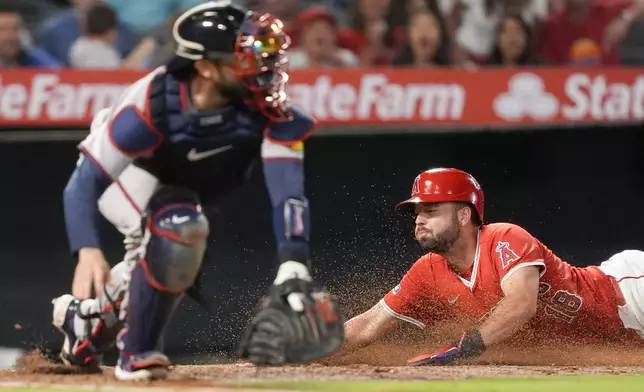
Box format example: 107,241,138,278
120,186,208,357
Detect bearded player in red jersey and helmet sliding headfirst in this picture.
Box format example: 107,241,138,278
334,168,644,366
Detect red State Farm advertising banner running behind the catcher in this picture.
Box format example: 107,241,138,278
0,68,644,127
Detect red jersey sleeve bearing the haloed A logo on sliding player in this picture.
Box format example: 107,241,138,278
490,224,546,286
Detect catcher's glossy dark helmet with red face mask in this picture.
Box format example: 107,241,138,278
167,0,292,121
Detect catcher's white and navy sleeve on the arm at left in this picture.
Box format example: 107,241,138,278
63,74,163,255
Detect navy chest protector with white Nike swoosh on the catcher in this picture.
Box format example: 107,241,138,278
135,74,268,201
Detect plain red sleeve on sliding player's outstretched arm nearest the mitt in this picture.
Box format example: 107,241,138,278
380,257,433,328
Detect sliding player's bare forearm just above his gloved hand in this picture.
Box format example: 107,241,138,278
479,297,537,347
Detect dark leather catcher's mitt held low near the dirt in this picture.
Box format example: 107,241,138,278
239,279,344,365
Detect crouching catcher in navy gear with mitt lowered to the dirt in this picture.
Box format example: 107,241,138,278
53,0,344,380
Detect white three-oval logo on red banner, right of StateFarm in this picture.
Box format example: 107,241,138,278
493,73,559,121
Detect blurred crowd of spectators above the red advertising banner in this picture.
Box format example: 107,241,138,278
0,0,644,69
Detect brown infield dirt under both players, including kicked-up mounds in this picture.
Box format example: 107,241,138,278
0,344,644,389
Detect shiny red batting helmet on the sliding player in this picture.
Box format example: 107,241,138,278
396,168,485,221
